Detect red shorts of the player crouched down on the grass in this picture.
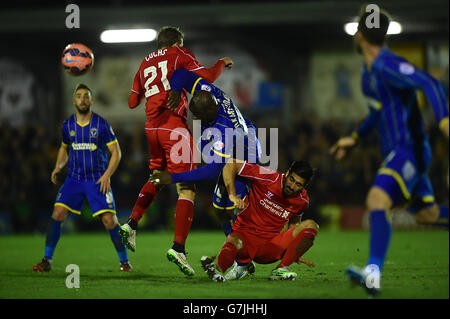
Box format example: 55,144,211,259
230,227,295,264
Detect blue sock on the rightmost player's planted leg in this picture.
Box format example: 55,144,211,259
368,210,392,271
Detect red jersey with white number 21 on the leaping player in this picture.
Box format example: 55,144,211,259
132,46,204,121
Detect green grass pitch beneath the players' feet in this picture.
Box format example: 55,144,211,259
0,230,449,299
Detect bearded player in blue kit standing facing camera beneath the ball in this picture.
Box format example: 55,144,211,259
33,84,132,272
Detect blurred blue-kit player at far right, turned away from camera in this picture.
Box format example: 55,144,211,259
330,7,449,295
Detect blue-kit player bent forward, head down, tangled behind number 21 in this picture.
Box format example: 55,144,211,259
150,70,260,279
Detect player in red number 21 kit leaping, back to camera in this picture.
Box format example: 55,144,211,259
120,26,233,276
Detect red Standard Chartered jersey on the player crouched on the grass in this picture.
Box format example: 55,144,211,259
233,162,309,238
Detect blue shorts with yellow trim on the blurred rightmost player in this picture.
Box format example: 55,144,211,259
374,147,435,213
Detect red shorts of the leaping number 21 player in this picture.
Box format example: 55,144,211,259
145,112,196,173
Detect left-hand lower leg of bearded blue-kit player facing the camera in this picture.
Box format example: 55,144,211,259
32,205,69,272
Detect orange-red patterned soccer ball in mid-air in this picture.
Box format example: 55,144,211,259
61,43,94,75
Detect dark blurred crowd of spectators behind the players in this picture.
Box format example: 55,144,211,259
0,104,449,233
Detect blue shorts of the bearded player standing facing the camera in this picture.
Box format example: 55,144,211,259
55,177,116,217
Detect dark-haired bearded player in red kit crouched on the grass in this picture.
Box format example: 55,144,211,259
201,159,319,282
